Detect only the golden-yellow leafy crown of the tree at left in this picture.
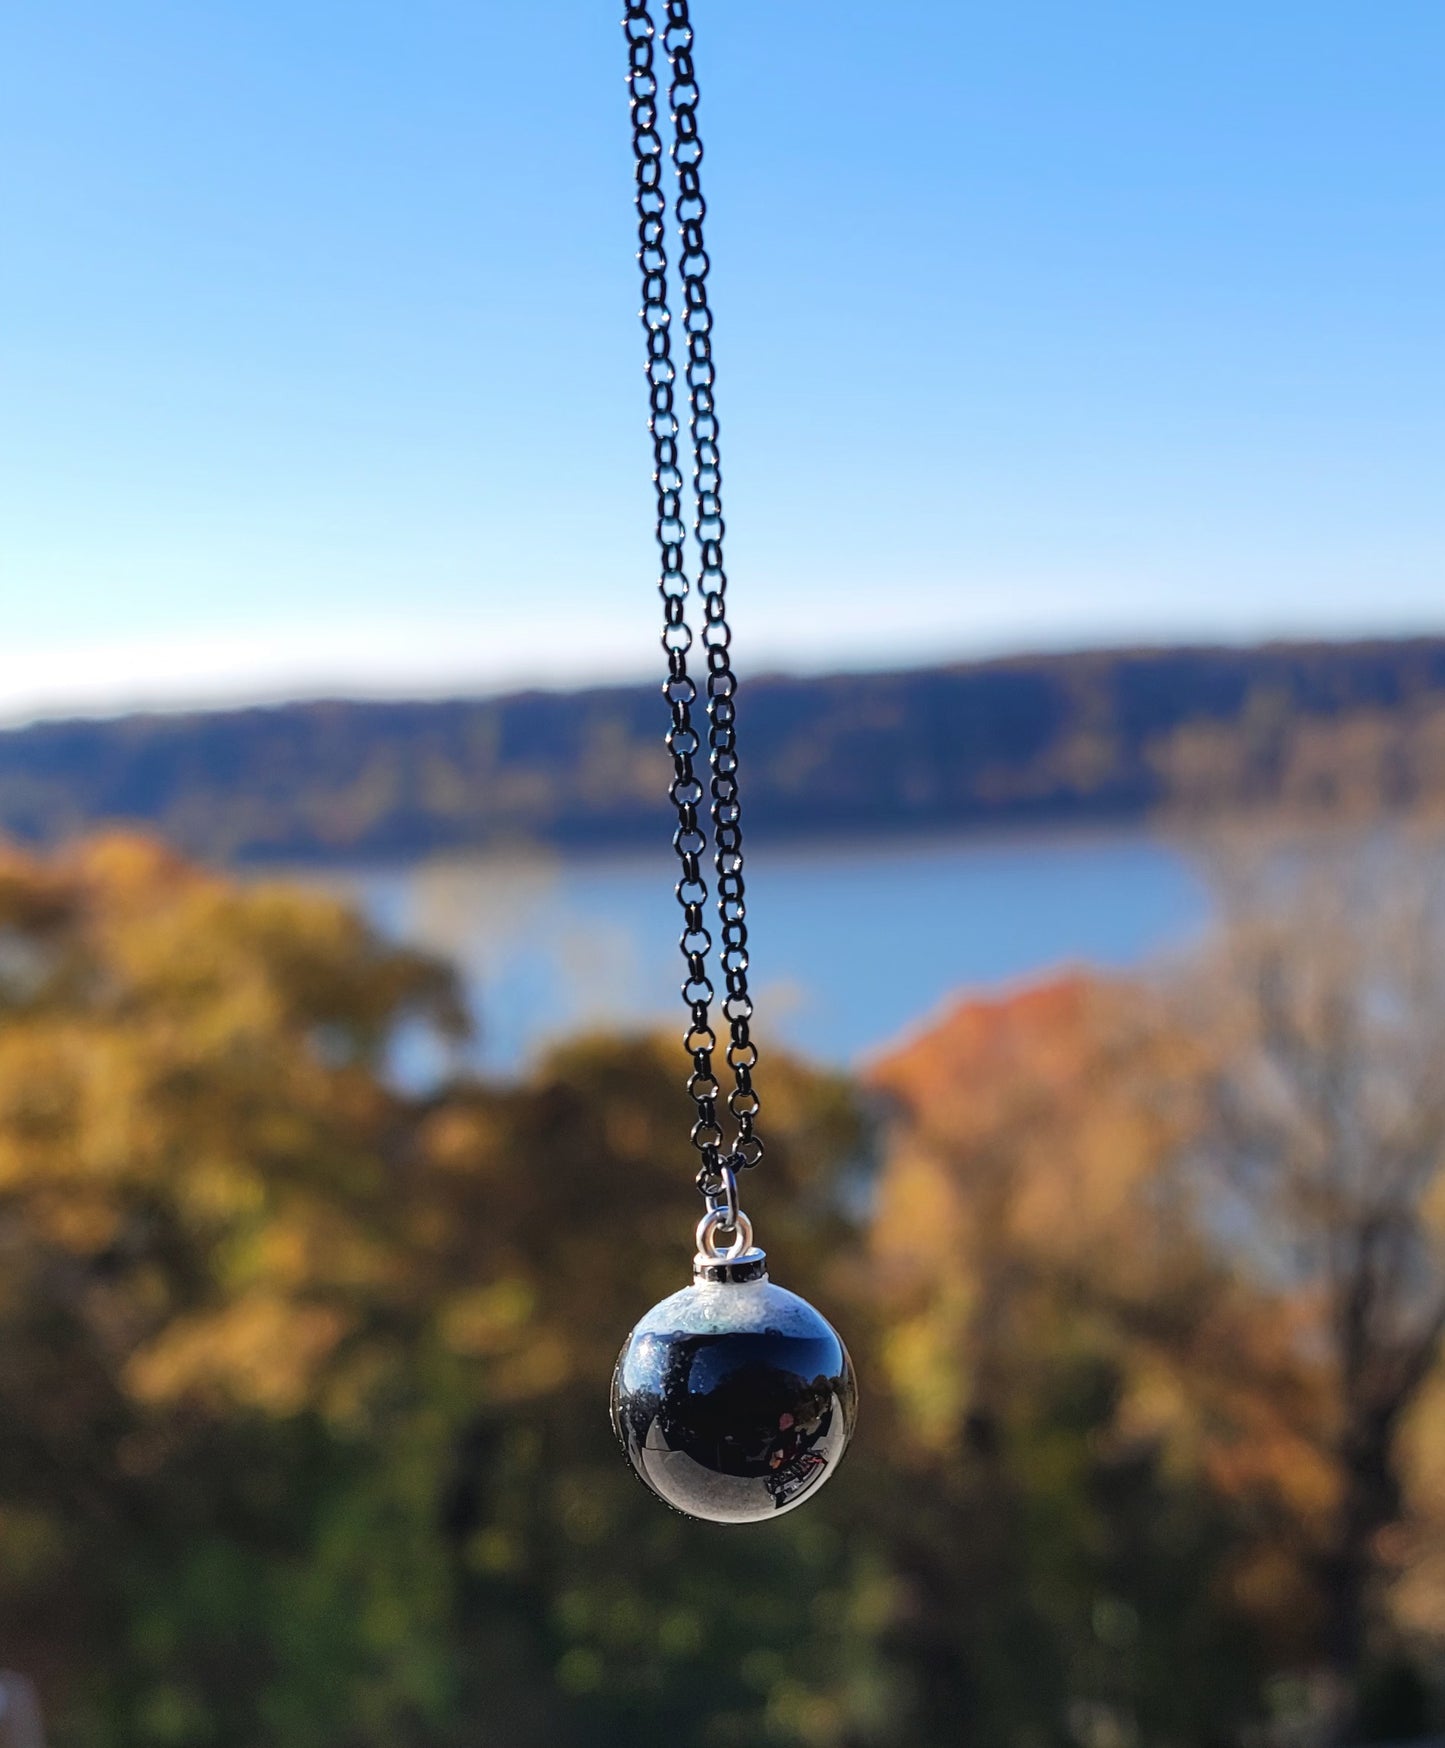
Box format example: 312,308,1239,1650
0,836,458,1433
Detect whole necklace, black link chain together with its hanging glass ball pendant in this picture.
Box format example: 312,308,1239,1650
612,0,858,1523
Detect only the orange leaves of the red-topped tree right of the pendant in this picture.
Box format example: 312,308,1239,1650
868,974,1335,1636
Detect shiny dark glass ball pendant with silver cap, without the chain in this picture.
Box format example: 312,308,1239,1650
612,1252,858,1524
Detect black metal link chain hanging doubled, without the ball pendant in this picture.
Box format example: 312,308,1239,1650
622,0,762,1199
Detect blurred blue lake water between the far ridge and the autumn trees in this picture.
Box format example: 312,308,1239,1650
311,834,1209,1079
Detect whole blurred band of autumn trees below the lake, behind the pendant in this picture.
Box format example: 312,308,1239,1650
0,837,1445,1748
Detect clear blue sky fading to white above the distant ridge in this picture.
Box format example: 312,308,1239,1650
0,0,1445,718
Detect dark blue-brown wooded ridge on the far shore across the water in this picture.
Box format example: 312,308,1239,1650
0,638,1445,867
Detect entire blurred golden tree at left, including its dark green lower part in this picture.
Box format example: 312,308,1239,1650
0,837,475,1745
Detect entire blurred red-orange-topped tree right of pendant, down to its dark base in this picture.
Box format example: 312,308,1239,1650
870,975,1300,1743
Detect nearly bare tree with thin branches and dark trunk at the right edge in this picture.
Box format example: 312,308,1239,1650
1186,836,1445,1729
